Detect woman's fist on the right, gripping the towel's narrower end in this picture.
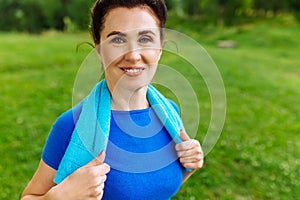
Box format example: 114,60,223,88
175,130,204,171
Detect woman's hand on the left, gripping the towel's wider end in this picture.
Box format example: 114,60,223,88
56,151,110,200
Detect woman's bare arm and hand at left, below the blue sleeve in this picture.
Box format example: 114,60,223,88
21,152,110,200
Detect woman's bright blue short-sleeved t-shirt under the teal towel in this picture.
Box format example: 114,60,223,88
42,104,183,200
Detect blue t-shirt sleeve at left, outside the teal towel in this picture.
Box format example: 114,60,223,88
42,104,82,170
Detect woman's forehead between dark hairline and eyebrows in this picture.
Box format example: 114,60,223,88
100,6,160,39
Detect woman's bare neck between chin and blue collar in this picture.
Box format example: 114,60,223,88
110,86,149,111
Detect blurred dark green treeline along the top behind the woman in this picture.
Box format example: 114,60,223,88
0,0,300,32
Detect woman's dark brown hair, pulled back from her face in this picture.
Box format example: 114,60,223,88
91,0,167,44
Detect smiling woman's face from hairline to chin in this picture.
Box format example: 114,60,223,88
96,7,162,90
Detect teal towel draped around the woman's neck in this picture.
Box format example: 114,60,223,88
54,79,190,184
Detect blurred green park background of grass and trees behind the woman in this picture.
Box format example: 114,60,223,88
0,0,300,200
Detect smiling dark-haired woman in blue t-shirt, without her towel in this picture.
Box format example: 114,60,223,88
22,0,203,200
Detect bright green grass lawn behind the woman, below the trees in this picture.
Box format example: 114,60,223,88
0,17,300,200
